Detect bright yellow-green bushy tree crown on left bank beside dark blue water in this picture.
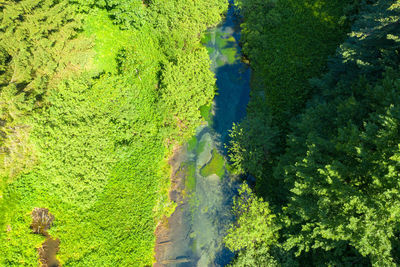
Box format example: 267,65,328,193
160,47,215,141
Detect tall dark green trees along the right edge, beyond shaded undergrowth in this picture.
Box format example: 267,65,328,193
277,1,400,266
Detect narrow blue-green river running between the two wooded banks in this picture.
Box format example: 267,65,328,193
156,4,250,267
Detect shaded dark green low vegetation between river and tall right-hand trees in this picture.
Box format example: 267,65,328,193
230,0,357,203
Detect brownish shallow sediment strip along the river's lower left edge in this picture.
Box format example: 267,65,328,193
153,146,190,267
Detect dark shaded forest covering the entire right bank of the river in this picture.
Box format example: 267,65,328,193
225,0,400,266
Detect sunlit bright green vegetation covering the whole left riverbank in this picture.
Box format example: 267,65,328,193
0,0,227,266
